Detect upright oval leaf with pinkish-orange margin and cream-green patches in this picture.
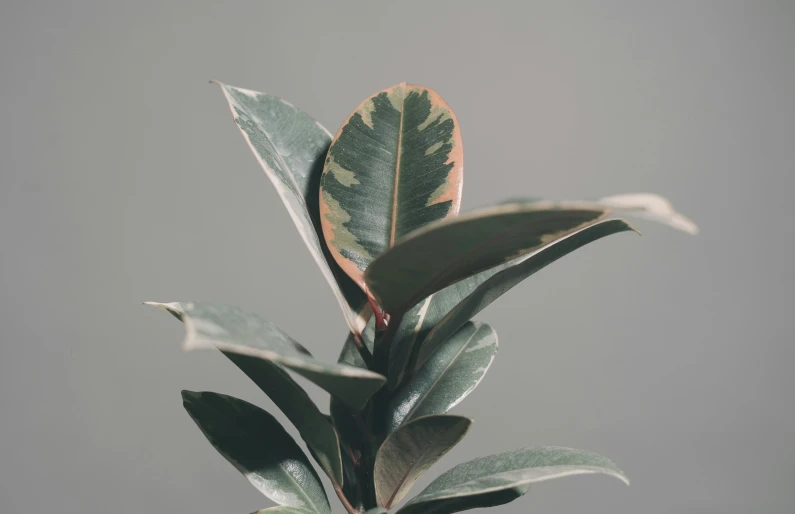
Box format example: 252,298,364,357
320,83,464,288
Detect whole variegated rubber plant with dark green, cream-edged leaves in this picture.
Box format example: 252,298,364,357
151,83,696,514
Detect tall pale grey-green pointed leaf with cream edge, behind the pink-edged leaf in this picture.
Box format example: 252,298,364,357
219,84,370,333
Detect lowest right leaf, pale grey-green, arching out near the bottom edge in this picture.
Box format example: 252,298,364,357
398,447,629,514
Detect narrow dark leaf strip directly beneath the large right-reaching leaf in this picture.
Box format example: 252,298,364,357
417,219,634,366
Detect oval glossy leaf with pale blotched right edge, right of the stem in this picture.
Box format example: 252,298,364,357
387,322,497,431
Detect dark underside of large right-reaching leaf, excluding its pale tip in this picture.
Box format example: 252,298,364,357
365,202,607,313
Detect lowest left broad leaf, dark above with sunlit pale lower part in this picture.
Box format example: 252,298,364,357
182,391,331,514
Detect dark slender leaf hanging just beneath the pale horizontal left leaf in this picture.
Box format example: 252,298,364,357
224,352,344,485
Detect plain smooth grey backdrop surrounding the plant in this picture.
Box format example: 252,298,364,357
0,0,795,514
